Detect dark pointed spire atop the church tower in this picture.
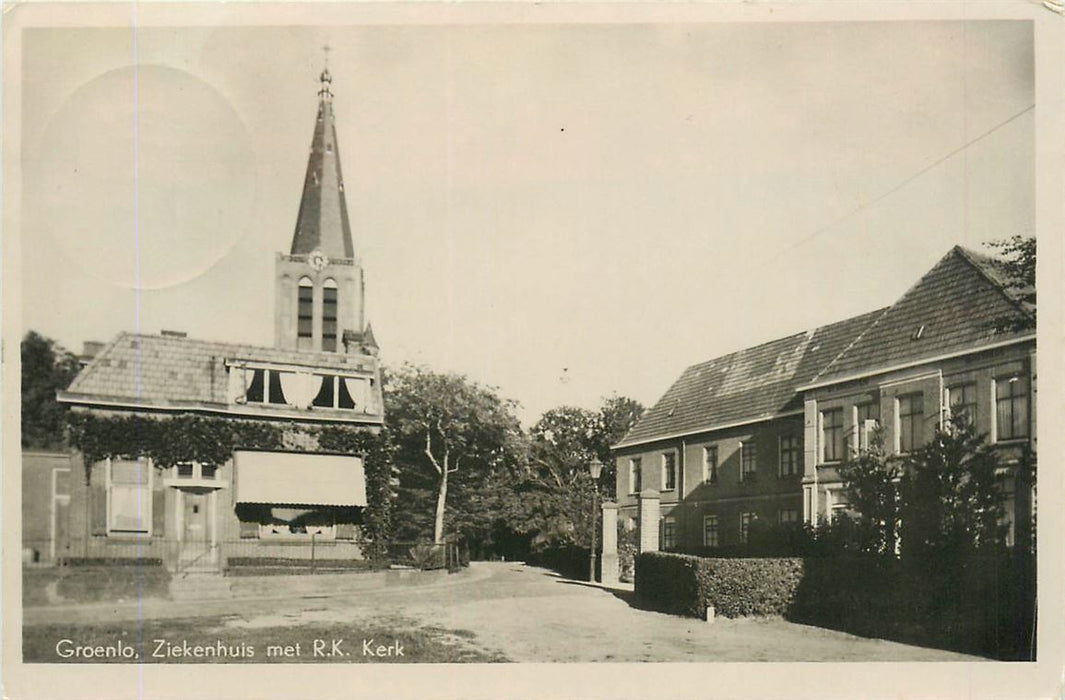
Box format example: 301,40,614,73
290,58,355,259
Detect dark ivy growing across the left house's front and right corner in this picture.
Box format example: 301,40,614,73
67,411,393,559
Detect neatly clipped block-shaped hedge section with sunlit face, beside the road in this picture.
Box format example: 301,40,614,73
636,552,803,618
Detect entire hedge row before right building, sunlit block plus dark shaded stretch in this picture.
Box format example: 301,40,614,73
636,552,1035,661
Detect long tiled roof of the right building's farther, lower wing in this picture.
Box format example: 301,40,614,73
616,309,883,447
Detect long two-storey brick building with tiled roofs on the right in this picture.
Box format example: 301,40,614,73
615,247,1035,550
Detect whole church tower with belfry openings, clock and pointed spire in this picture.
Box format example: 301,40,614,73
274,61,377,355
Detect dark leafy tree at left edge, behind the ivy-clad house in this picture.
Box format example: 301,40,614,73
21,330,81,447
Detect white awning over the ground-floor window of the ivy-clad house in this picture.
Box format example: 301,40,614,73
233,450,366,506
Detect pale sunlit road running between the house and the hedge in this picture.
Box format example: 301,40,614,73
26,563,976,662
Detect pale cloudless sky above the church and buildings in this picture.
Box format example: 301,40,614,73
20,21,1035,423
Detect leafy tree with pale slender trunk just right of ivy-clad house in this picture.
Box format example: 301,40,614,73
386,365,522,543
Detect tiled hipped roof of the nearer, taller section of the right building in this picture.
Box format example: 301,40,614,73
812,246,1031,385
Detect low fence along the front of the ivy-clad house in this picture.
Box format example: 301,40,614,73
22,536,469,575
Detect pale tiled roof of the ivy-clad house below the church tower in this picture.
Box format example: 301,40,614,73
60,332,380,422
